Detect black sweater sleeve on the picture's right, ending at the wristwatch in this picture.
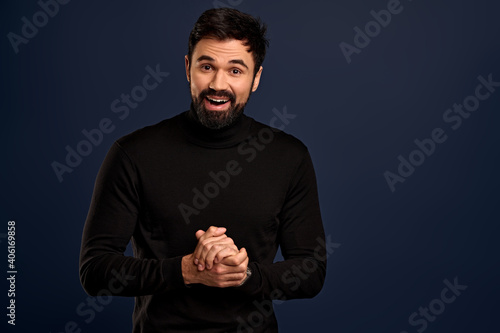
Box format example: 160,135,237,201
240,150,327,300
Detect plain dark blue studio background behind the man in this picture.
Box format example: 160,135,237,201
0,0,500,333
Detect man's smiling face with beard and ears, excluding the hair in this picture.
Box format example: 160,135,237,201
185,38,262,129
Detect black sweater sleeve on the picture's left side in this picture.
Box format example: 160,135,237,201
80,143,184,296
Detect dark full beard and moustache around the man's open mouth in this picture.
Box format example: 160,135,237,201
191,88,251,130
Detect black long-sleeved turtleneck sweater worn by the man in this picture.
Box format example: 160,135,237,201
80,111,326,333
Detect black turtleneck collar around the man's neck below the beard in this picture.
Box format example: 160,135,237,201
180,102,252,148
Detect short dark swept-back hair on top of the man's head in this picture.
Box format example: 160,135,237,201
188,8,269,75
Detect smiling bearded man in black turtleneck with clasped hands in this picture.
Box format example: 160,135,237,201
80,8,326,332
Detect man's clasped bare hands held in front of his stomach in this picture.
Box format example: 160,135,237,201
182,226,248,288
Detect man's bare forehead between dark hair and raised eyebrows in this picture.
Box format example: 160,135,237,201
193,38,254,67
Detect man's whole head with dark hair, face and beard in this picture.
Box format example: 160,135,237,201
185,8,269,129
